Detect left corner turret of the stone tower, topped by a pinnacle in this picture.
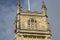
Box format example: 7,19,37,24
14,0,21,33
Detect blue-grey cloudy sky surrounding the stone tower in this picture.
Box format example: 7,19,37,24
0,0,60,40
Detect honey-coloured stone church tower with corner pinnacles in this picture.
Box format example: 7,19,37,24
14,0,52,40
